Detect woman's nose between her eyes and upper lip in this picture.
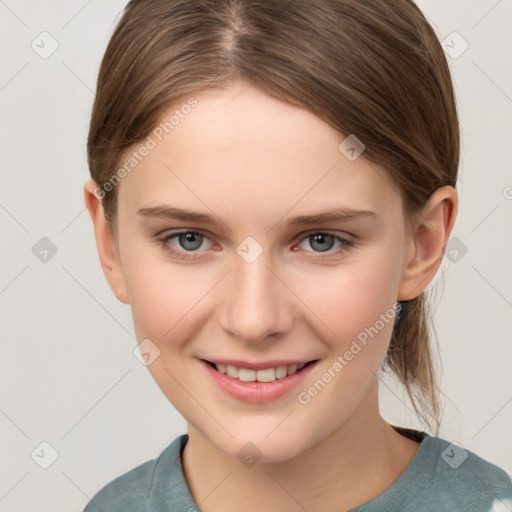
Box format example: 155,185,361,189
220,247,294,344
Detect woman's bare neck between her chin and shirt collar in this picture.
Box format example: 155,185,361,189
183,389,419,512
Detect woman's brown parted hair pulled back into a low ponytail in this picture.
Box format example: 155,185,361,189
87,0,460,433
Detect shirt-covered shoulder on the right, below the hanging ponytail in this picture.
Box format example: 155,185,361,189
418,437,512,512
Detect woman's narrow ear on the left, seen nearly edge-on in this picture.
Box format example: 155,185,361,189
84,179,129,304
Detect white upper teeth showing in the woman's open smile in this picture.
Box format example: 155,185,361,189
202,359,318,382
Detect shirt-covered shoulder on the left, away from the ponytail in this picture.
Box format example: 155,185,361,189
83,436,183,512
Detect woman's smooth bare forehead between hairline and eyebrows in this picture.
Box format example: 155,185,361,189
119,83,398,221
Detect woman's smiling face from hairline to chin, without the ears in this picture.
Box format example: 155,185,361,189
108,83,408,461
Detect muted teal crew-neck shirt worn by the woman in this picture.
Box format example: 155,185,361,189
83,427,512,512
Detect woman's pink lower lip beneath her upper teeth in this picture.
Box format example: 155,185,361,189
199,359,318,403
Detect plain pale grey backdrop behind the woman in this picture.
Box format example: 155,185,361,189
0,0,512,512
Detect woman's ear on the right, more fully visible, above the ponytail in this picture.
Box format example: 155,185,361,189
397,186,458,301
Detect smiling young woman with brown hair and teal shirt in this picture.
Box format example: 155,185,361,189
85,0,512,512
